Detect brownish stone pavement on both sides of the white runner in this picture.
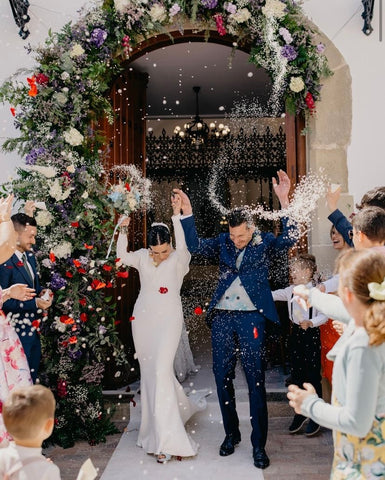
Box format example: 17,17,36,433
45,402,333,480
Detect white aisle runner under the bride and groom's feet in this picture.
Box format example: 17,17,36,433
100,394,264,480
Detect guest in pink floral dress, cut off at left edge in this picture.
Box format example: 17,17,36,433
0,196,35,447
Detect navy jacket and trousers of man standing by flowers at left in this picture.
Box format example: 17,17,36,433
0,252,42,382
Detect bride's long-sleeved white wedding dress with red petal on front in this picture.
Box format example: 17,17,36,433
117,215,206,457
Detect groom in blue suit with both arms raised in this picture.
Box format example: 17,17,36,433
174,170,295,468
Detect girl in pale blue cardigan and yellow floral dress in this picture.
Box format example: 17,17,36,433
287,249,385,480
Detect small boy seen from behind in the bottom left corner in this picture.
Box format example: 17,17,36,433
0,385,60,480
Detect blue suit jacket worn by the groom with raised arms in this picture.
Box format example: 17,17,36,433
182,216,296,323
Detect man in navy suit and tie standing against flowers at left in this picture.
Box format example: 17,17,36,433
0,213,53,383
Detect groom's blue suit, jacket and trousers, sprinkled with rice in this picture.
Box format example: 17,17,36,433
182,216,296,448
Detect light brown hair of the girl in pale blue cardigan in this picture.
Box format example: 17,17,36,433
339,248,385,345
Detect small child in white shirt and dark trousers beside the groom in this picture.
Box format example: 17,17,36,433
272,253,327,437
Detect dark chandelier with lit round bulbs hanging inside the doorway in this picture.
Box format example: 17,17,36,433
174,87,230,148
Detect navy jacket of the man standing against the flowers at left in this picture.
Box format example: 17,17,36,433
0,252,43,321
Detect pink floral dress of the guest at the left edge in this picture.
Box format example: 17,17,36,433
0,289,32,447
